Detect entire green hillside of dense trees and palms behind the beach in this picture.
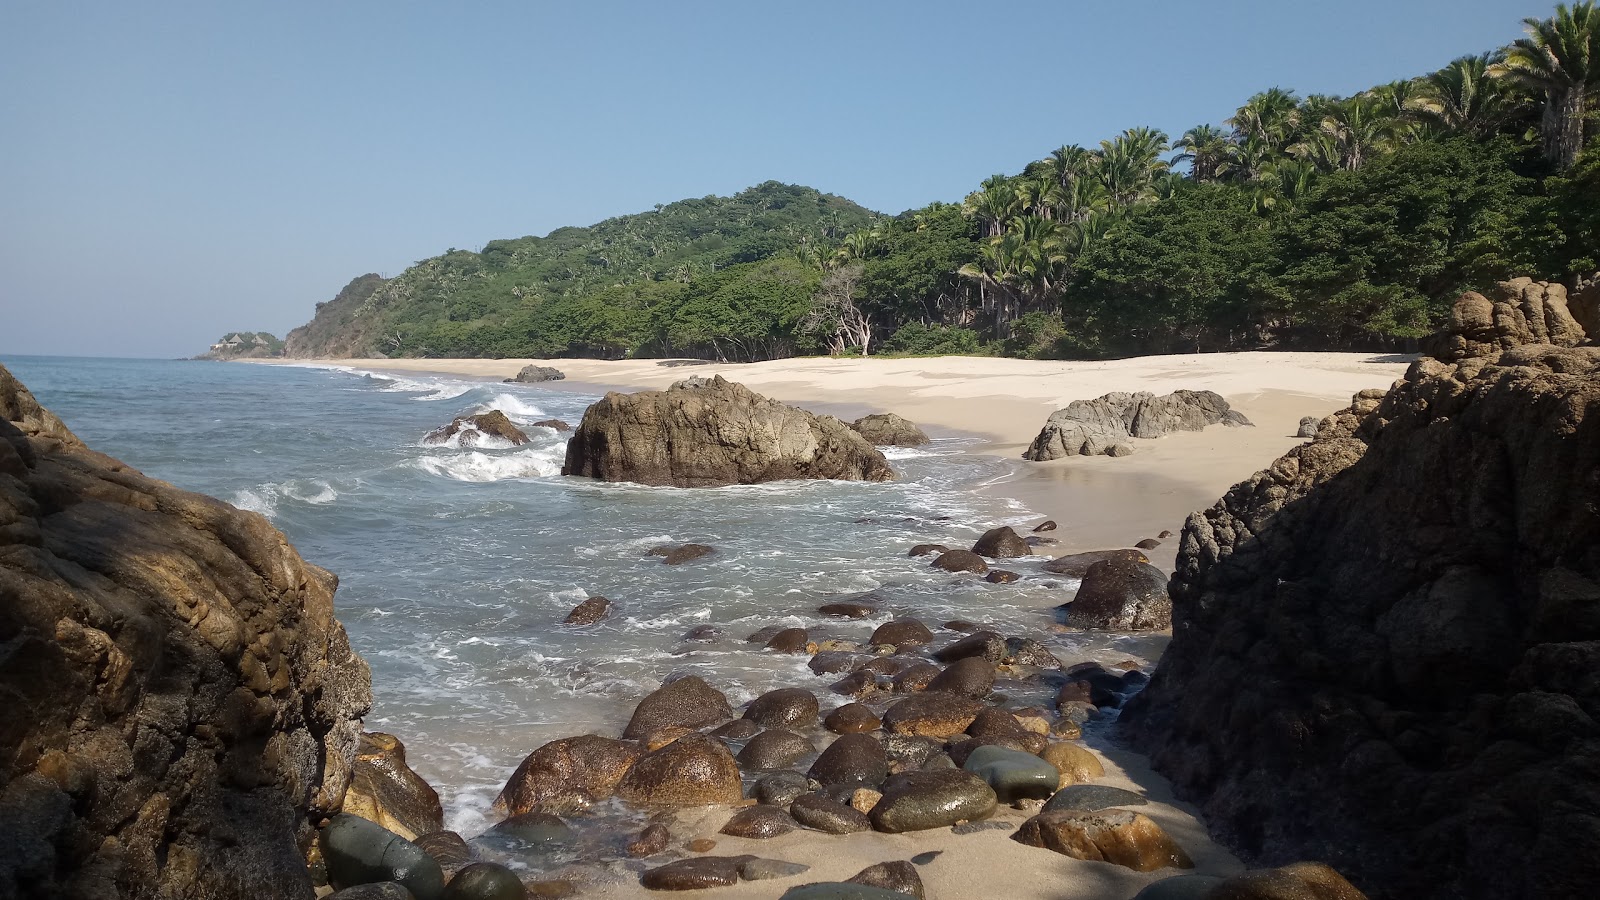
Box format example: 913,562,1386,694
290,2,1600,360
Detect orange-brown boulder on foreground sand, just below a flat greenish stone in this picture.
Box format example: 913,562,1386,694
1011,809,1194,871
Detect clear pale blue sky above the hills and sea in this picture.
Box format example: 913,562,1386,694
0,0,1554,357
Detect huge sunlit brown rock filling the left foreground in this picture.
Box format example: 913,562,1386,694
0,367,371,900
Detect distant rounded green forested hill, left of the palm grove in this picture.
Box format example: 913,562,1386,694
286,181,874,359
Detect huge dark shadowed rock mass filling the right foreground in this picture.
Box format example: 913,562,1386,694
1123,280,1600,898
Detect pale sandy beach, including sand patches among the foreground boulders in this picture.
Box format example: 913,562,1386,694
249,352,1410,900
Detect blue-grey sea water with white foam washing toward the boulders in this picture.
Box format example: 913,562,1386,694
0,357,1152,836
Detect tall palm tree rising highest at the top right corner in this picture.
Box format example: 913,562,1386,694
1491,0,1600,170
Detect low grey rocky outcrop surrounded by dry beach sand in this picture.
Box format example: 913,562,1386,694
1022,391,1250,461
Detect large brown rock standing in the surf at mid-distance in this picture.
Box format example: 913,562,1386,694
562,375,894,487
